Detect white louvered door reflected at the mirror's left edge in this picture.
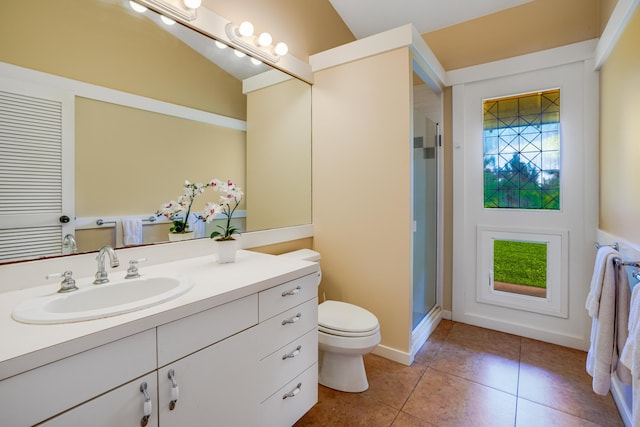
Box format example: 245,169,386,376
0,79,73,261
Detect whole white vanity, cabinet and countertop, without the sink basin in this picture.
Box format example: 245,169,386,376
0,251,318,427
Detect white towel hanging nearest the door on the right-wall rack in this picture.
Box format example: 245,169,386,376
586,248,630,395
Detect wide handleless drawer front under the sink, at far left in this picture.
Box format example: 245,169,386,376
0,329,156,426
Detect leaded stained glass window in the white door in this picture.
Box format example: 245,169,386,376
483,89,560,210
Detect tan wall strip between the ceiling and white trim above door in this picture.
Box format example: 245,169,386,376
423,0,600,70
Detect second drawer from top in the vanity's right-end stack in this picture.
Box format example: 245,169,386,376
257,298,318,360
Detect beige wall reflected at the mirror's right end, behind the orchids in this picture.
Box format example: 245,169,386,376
246,79,311,231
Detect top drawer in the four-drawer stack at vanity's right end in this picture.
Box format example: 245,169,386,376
259,273,319,322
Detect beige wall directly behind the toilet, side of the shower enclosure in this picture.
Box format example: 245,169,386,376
312,48,411,352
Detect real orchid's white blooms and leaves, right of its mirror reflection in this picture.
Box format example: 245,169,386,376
202,179,244,240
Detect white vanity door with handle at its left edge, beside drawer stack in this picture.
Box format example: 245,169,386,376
158,327,261,427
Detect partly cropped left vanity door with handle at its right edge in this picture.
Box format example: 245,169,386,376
39,372,158,427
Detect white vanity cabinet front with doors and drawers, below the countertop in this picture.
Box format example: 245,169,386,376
0,260,318,427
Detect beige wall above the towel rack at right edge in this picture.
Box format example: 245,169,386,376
600,9,640,244
